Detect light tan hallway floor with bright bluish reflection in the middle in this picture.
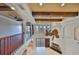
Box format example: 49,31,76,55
24,43,61,55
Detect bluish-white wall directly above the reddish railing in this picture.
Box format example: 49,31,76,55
0,24,22,37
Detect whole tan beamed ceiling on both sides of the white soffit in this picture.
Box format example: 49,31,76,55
0,3,79,22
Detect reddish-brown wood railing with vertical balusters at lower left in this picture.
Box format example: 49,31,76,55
0,33,22,55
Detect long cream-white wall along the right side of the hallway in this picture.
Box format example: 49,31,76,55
35,17,79,55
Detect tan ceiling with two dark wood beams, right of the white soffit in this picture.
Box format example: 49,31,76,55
29,3,79,22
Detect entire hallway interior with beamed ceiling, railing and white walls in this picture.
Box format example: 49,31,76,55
0,3,79,55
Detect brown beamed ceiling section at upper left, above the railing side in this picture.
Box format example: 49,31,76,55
0,3,20,21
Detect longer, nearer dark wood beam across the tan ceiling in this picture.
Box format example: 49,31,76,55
32,12,78,17
